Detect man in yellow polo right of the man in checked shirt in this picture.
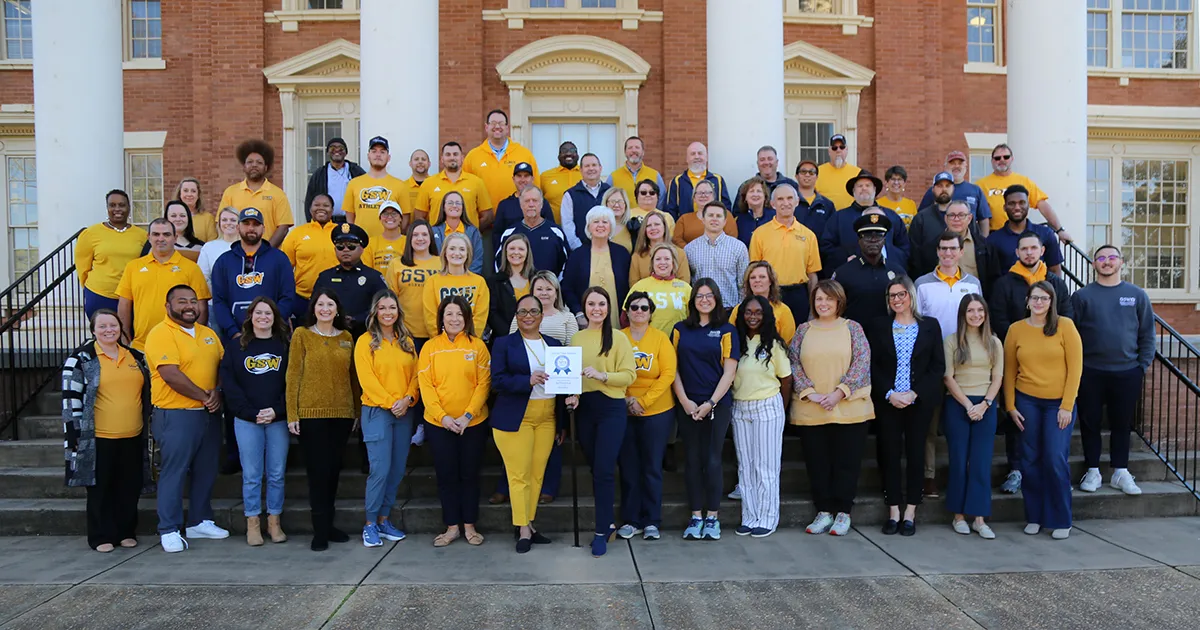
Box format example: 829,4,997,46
750,184,821,322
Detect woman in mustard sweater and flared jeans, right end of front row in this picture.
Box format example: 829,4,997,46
1004,281,1084,540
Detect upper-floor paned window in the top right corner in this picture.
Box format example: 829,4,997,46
1087,0,1195,70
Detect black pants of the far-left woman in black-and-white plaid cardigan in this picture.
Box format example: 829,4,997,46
88,436,145,548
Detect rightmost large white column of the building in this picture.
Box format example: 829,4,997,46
1006,0,1087,239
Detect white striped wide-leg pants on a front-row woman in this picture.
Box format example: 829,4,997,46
733,394,784,529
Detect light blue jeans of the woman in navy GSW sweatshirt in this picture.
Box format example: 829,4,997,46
233,418,292,518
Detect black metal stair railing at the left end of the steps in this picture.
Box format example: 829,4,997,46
0,229,88,439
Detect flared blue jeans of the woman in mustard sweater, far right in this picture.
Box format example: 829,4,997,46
1014,391,1075,529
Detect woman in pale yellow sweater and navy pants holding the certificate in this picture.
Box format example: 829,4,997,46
571,287,636,558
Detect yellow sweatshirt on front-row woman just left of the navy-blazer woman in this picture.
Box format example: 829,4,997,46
418,332,492,427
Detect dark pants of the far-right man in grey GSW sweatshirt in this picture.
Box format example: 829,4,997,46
1079,367,1144,468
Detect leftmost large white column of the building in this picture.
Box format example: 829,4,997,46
32,0,125,254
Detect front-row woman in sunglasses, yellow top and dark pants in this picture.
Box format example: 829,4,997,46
617,290,686,540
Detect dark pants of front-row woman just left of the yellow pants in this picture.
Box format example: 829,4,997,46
425,422,491,527
